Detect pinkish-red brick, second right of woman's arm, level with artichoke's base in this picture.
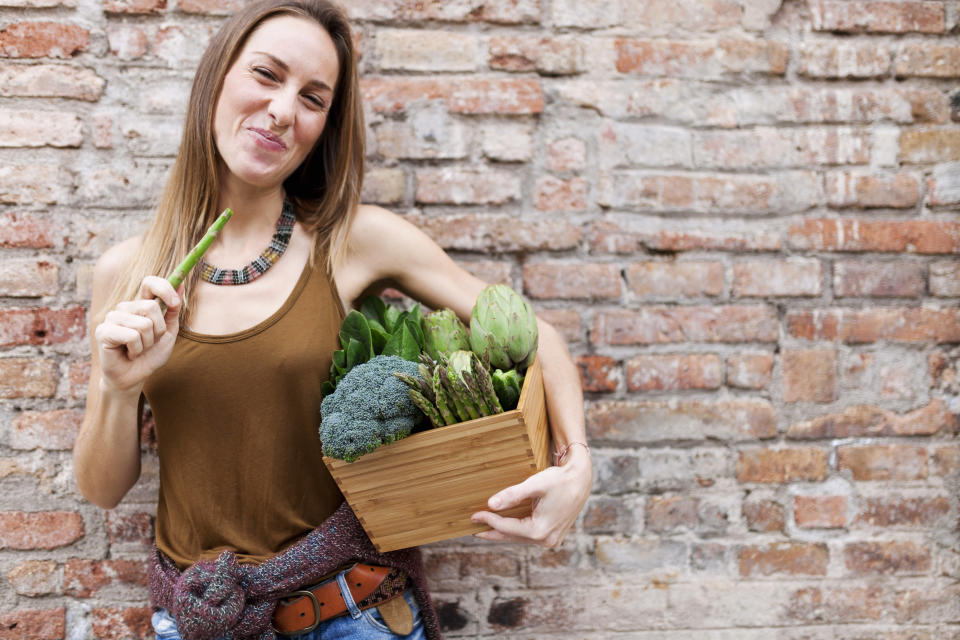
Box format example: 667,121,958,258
627,354,723,391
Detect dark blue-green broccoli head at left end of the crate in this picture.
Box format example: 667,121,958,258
320,356,423,462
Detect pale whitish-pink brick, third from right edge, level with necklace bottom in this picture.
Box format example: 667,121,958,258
733,258,823,297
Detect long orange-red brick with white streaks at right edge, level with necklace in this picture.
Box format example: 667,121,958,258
790,219,960,254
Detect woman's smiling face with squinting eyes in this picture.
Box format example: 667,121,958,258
213,16,339,188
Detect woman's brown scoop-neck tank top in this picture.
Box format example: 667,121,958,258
144,259,344,569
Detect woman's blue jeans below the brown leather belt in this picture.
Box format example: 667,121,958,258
151,572,426,640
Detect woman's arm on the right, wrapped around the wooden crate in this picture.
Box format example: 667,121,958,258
337,206,593,547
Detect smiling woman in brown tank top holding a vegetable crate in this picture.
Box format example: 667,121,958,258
74,0,591,638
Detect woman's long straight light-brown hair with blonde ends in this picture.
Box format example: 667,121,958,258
103,0,365,319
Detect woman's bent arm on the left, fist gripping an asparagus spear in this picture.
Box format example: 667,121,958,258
73,239,180,509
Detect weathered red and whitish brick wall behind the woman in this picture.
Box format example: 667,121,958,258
0,0,960,640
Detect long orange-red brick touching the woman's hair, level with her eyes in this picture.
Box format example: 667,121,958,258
360,76,544,115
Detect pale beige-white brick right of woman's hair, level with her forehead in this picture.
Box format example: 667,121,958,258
374,29,479,71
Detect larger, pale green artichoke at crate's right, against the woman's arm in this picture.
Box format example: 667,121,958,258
470,284,538,371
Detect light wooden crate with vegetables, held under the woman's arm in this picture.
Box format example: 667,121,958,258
323,361,550,552
